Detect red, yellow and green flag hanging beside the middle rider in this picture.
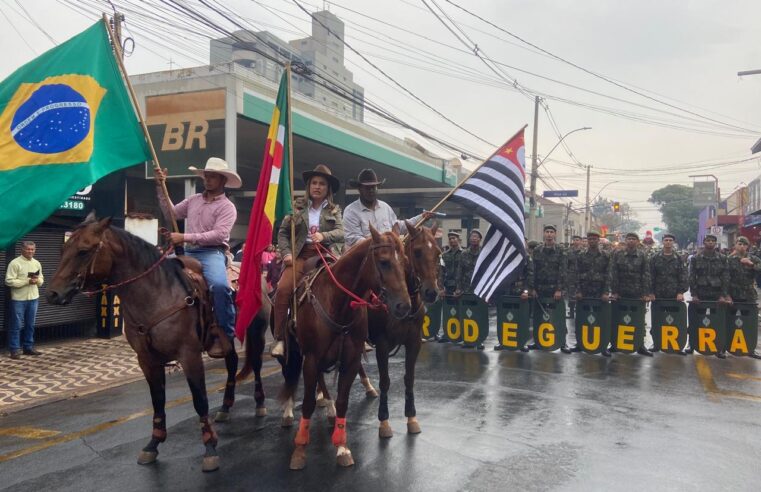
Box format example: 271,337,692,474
235,70,292,341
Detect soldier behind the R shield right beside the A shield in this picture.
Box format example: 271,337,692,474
684,234,732,359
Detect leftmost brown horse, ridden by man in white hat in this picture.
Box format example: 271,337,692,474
47,214,243,471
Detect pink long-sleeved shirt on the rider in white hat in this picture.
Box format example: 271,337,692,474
158,193,238,246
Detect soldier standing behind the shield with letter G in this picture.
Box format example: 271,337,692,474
528,225,571,354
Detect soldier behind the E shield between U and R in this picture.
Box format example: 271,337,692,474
610,232,653,357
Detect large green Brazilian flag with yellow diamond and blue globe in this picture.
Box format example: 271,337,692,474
0,21,150,247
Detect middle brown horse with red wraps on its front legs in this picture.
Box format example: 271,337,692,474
283,226,410,470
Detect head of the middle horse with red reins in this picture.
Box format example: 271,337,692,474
370,225,411,318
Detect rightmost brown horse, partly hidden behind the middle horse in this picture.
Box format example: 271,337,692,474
368,221,441,437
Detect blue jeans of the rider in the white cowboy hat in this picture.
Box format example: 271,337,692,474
185,248,235,338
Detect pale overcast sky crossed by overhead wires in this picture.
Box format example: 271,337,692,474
0,0,761,229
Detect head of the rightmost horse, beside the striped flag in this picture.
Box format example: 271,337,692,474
404,220,441,304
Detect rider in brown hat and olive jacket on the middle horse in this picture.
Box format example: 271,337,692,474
270,164,344,357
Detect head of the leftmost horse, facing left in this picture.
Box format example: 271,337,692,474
46,213,113,304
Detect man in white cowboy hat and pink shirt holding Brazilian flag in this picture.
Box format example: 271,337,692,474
155,157,241,339
